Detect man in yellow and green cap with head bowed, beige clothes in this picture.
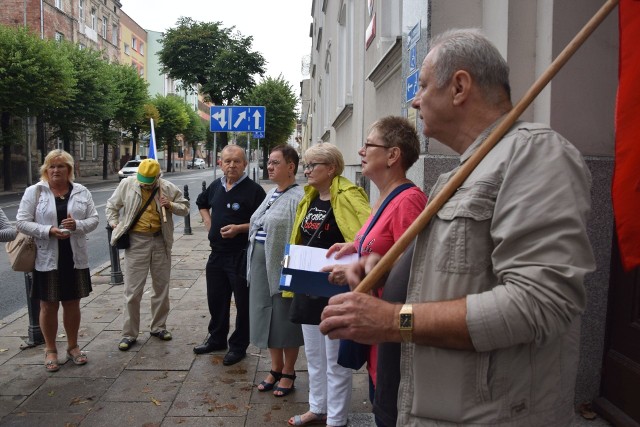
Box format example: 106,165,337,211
105,159,189,351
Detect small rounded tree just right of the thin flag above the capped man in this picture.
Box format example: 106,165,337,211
152,95,189,172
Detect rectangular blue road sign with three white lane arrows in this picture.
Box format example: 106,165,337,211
210,105,266,132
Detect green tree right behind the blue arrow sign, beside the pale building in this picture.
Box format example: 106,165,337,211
242,75,298,178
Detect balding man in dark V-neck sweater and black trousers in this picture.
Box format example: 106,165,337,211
193,145,266,365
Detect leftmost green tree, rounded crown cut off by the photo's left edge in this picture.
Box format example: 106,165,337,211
0,25,76,191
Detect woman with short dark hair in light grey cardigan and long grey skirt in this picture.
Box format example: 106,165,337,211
247,145,304,397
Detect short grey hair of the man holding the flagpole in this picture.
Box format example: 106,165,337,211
431,28,511,103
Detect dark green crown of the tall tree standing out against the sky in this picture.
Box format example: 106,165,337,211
158,17,265,105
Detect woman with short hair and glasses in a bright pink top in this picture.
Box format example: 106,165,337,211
326,116,427,427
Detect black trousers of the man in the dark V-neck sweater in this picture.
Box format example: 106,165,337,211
206,250,249,353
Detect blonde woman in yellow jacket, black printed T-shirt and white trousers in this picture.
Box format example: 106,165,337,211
289,143,371,426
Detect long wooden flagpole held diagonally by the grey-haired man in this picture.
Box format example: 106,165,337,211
354,0,618,292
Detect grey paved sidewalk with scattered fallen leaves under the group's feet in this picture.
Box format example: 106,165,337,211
0,219,373,426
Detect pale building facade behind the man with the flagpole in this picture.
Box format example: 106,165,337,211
302,0,640,423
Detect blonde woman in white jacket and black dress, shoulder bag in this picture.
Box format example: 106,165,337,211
16,150,99,372
